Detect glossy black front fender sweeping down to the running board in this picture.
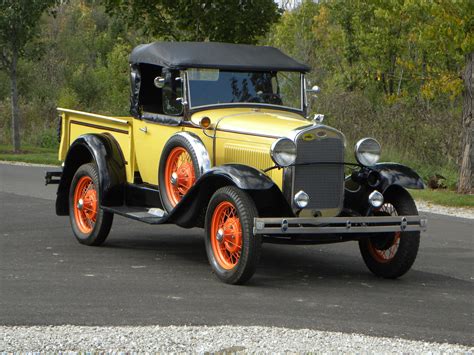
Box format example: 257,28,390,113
167,164,293,228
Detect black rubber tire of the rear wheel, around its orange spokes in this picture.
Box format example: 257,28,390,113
69,163,114,246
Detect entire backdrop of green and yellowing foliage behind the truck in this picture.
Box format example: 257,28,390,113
0,0,468,195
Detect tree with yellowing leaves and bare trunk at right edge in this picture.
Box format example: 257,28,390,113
412,0,474,193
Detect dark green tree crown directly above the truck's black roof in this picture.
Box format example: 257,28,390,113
103,0,280,43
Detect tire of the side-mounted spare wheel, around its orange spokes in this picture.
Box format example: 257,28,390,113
158,135,201,212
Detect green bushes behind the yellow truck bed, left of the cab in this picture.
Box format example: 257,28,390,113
0,0,139,146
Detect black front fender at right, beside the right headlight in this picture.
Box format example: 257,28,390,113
372,163,425,192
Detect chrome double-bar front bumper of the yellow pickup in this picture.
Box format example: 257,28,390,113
253,216,427,236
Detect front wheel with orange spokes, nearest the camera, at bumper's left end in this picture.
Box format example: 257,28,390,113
205,186,262,284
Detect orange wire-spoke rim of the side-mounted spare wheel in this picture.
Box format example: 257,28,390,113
165,147,196,207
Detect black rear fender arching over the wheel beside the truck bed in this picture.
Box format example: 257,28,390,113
56,133,127,216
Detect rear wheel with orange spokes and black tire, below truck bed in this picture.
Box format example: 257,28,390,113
69,163,114,245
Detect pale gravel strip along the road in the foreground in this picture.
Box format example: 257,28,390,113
0,325,474,354
